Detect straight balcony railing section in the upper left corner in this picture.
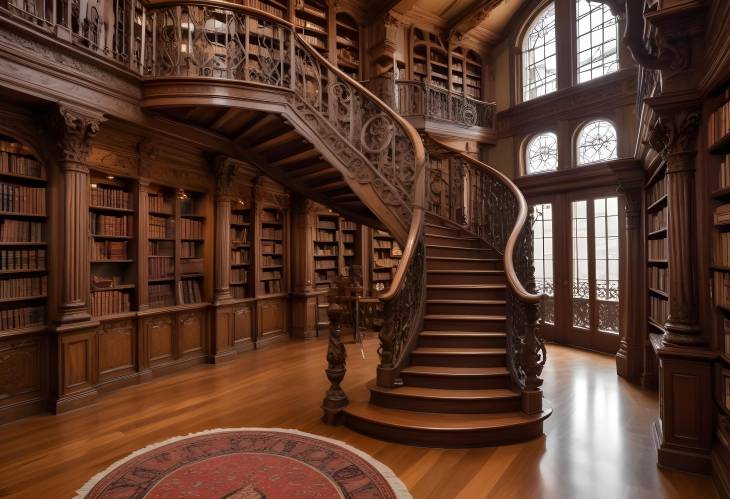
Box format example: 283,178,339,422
0,0,144,70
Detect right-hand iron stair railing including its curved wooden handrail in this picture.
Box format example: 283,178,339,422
426,139,545,402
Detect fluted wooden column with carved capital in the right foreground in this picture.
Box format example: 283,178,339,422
648,111,703,345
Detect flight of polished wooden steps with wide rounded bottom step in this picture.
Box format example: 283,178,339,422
343,216,552,447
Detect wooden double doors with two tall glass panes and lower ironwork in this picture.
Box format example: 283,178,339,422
565,196,623,353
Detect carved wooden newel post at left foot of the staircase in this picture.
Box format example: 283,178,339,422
322,283,348,425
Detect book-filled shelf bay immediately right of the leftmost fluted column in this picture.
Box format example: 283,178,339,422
89,171,136,318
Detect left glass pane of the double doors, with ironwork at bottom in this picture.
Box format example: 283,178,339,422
571,201,591,329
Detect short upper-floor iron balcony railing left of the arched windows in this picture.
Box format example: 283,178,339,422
395,80,496,128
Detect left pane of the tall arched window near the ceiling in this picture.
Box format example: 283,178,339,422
522,3,558,101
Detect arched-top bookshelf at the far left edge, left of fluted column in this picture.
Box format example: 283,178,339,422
0,135,48,336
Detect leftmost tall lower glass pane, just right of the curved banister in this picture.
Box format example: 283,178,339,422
532,203,555,324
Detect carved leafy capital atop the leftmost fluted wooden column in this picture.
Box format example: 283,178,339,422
51,106,104,167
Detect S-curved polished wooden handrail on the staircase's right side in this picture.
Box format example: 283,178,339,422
434,140,544,303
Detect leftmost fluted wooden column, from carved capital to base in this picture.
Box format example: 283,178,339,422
53,106,102,324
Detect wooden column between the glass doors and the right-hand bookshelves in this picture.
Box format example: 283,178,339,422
616,188,644,379
